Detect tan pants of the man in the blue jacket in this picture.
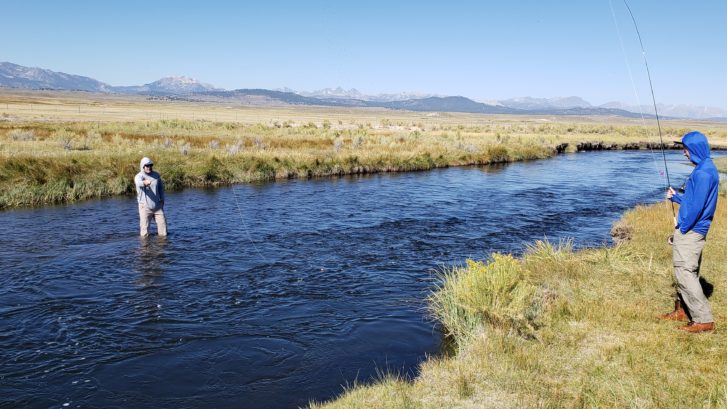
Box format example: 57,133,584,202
672,229,714,323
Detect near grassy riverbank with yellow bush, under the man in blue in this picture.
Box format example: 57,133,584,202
311,196,727,408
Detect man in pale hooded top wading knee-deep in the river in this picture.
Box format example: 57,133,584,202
134,157,167,237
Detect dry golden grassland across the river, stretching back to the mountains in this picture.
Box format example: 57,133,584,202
0,90,727,208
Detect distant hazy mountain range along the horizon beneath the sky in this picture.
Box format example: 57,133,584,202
0,62,727,120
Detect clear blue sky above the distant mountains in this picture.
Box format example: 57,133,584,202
0,0,727,108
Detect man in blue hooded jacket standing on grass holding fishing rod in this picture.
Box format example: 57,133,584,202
659,131,719,333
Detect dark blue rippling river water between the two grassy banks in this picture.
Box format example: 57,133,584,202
0,152,708,408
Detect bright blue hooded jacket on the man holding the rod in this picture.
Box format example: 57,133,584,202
671,131,719,236
